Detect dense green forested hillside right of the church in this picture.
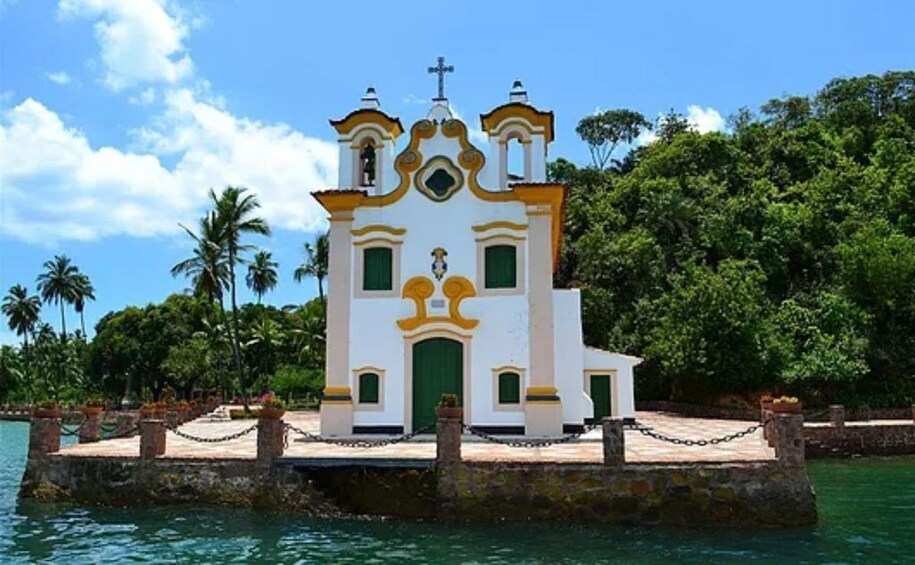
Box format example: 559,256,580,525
550,72,915,406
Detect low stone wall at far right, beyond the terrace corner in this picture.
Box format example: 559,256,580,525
804,423,915,458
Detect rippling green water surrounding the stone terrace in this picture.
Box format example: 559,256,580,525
0,422,915,564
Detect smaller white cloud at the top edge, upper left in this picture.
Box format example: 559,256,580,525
58,0,194,91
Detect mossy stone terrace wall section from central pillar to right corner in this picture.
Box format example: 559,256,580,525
438,463,817,526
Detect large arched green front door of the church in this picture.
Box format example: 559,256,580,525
413,337,464,430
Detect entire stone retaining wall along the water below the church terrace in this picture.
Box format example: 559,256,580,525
22,455,816,526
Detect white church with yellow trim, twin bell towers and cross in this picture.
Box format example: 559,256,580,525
313,58,641,436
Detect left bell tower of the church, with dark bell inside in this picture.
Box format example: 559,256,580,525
330,86,404,195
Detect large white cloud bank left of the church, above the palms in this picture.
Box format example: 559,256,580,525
0,90,337,245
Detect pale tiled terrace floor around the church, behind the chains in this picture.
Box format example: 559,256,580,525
61,412,774,463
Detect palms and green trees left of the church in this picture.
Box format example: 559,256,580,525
0,187,327,402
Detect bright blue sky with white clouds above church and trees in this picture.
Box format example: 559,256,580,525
0,0,915,342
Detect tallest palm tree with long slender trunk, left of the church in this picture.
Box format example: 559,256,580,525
210,186,270,400
